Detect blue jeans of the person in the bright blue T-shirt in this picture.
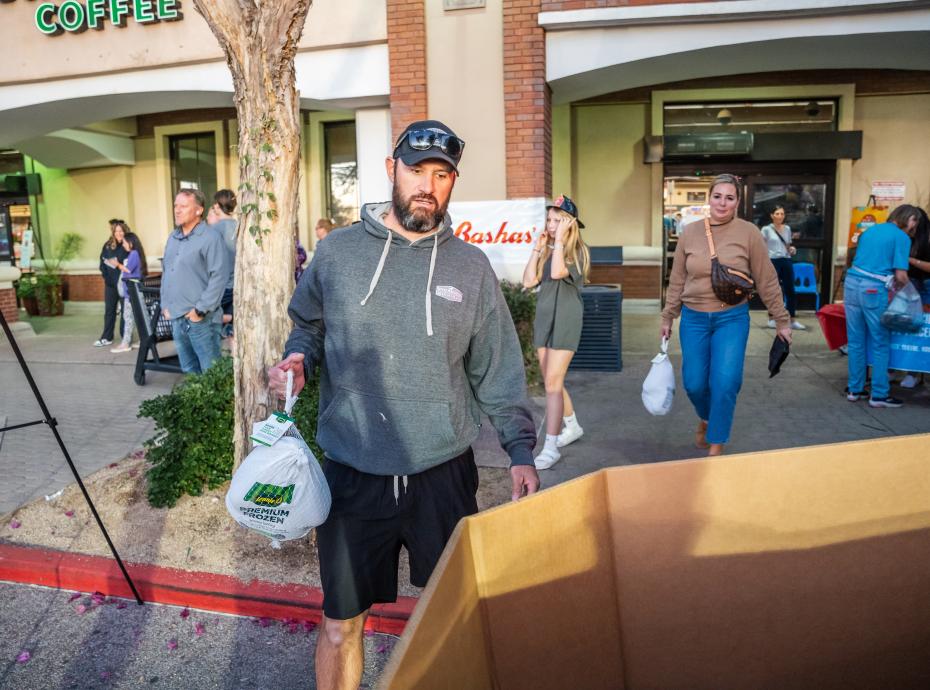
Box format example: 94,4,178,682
843,272,890,400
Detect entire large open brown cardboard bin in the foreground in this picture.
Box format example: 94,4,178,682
381,435,930,690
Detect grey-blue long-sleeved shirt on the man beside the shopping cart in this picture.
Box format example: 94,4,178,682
161,221,229,321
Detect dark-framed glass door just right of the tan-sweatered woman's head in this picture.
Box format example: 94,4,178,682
744,175,833,309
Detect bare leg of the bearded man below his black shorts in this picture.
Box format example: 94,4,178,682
316,611,368,690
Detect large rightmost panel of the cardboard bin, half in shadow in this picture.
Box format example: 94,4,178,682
608,436,930,690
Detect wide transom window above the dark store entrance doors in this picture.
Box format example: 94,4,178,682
663,99,836,136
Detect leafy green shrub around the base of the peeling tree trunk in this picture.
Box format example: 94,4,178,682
139,357,322,508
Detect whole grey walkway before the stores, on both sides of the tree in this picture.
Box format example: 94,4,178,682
0,303,930,515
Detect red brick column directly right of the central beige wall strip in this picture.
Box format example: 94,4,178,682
503,0,552,199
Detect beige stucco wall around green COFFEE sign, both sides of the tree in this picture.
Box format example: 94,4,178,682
0,0,387,85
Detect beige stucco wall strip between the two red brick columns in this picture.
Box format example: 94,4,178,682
426,0,507,201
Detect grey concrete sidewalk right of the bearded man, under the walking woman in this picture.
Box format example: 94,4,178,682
478,312,930,486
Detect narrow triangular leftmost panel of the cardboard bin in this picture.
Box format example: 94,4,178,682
379,521,493,690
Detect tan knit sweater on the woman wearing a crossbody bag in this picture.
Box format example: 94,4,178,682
662,218,791,328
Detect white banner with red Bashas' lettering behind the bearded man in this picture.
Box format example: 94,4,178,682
449,197,546,283
